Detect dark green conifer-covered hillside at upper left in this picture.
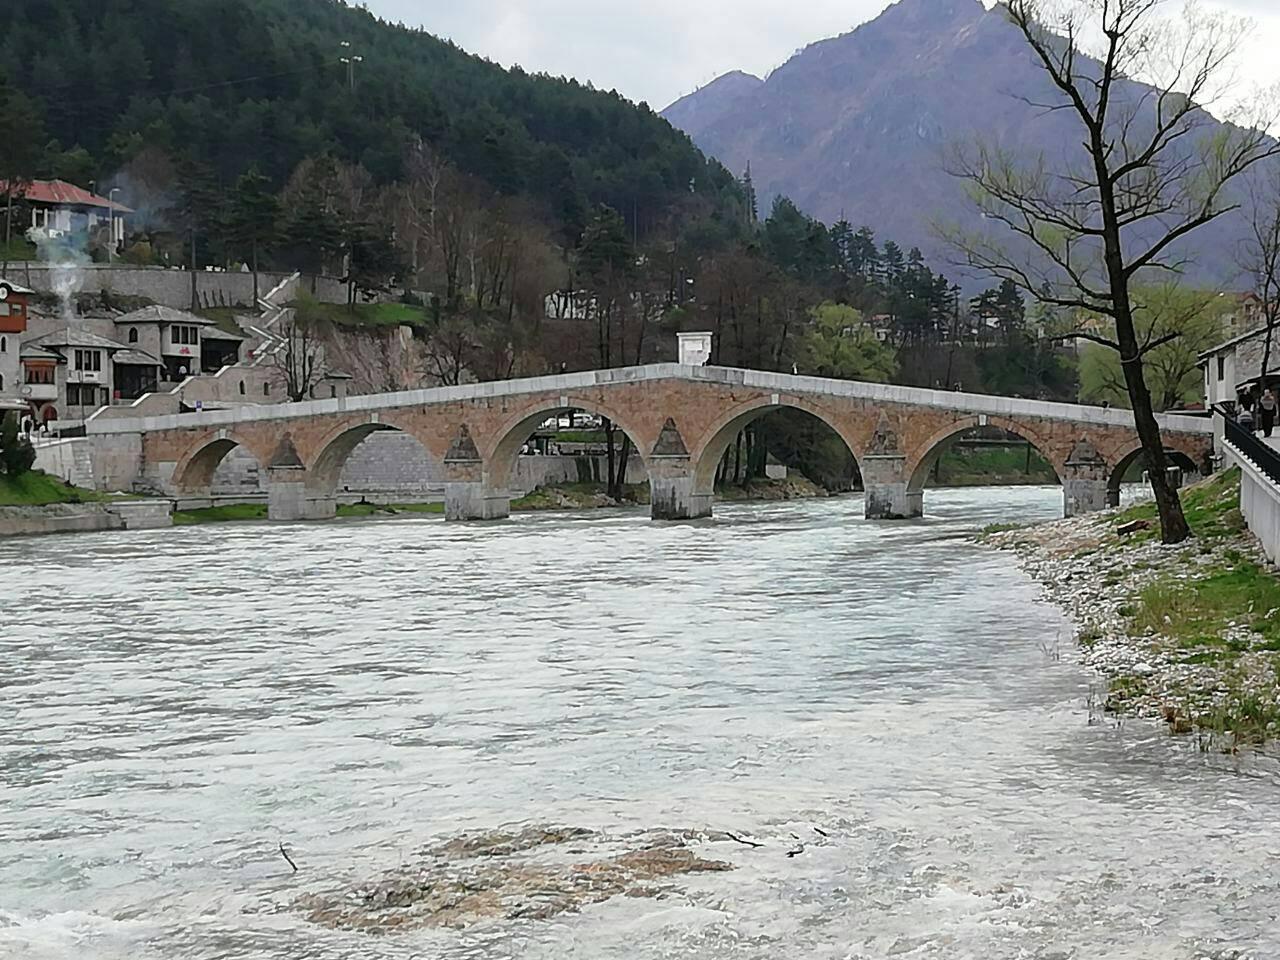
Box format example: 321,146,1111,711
0,0,739,234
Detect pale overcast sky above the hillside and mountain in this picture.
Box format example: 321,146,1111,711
366,0,1280,109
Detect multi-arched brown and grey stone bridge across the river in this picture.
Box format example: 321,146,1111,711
87,364,1213,520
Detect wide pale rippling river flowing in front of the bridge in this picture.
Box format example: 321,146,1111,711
0,488,1280,960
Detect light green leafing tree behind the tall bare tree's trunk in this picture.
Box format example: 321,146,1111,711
1080,284,1225,411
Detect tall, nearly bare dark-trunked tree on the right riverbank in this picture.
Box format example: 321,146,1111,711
943,0,1280,543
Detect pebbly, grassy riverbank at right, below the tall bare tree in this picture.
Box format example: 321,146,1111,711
982,471,1280,749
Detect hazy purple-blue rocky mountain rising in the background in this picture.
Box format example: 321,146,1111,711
663,0,1243,285
